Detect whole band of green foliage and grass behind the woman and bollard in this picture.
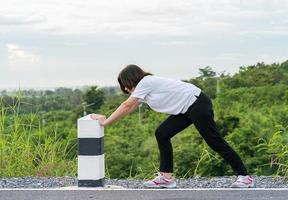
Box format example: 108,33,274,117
0,61,288,179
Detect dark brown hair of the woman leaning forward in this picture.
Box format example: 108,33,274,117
118,64,153,94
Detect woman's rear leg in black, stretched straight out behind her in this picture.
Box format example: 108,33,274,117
187,94,247,176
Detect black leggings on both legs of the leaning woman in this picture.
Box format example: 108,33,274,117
155,92,247,175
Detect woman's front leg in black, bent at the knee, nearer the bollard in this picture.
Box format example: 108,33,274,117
155,114,192,173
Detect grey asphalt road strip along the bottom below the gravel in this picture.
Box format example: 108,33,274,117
0,189,288,200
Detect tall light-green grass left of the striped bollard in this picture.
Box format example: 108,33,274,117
0,92,77,177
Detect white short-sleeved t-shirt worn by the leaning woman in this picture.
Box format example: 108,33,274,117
131,75,201,115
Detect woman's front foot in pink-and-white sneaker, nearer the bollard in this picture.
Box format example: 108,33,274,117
143,172,176,188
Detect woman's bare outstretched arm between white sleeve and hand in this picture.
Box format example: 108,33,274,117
103,97,141,126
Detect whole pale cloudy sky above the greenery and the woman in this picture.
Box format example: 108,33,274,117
0,0,288,89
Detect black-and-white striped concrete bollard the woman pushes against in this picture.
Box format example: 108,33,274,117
77,115,105,187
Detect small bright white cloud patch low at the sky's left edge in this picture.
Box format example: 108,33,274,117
6,44,40,71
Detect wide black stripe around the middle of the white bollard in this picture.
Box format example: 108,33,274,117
78,137,104,156
